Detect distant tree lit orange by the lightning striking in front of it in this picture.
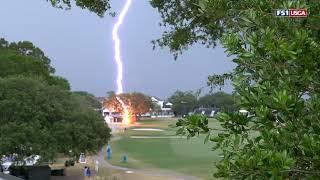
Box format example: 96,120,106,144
104,92,152,115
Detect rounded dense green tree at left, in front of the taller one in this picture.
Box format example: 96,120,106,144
0,76,110,161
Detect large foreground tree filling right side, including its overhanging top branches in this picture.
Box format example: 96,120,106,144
151,0,320,179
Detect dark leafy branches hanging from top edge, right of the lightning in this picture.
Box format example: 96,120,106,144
150,0,228,58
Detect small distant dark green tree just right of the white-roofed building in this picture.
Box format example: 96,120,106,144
168,91,197,115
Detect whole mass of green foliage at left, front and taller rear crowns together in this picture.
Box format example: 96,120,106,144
0,40,110,161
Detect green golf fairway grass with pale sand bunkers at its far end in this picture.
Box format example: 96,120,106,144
110,120,219,179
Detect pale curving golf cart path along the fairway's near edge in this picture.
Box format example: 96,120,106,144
93,137,199,180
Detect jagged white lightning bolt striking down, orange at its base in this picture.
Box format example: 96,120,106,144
112,0,132,125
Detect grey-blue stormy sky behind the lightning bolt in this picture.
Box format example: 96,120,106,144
0,0,233,98
